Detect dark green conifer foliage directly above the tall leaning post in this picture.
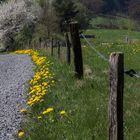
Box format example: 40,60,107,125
53,0,90,29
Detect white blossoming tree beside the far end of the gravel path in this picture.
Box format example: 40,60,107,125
0,0,41,51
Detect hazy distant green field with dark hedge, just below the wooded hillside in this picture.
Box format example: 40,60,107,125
90,15,140,31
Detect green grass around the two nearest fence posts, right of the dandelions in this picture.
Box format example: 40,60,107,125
23,30,140,140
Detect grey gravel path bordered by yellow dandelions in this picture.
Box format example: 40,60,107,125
0,54,34,140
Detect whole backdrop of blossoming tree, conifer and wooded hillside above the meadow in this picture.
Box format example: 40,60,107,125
0,0,140,51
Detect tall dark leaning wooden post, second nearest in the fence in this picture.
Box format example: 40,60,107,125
70,22,83,78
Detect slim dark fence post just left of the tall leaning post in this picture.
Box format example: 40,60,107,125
65,32,71,65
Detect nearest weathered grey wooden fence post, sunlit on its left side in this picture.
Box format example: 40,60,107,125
109,53,124,140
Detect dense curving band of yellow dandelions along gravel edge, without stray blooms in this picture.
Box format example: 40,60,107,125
15,50,54,106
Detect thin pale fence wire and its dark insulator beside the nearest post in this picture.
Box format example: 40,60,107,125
80,33,140,78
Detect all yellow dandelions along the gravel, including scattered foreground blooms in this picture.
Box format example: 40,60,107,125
15,50,67,137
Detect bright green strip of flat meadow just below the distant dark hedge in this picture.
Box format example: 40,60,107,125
86,29,140,43
